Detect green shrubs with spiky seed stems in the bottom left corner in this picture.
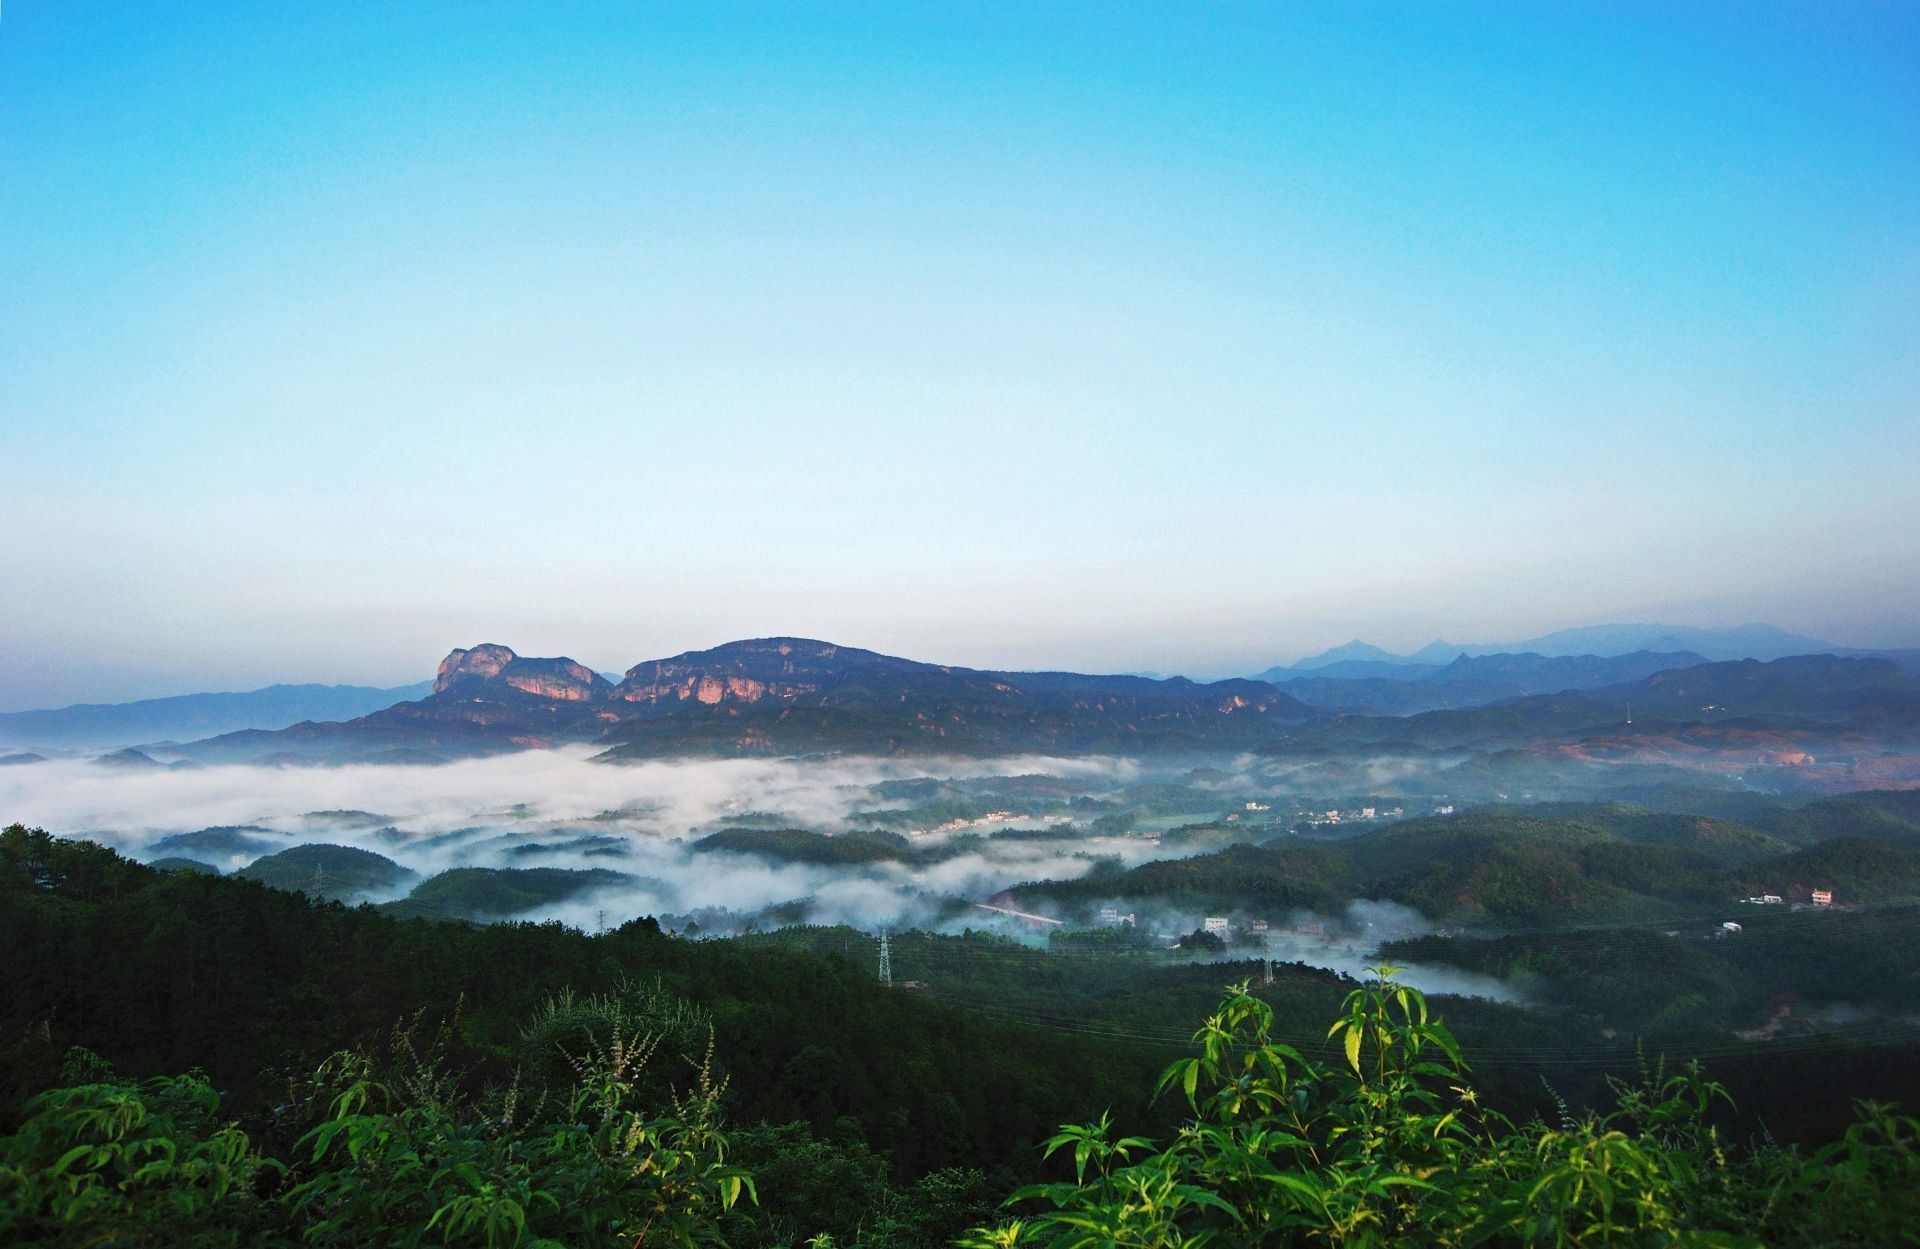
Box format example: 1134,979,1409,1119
0,1030,753,1249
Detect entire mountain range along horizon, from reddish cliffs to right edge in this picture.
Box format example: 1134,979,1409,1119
135,637,1920,764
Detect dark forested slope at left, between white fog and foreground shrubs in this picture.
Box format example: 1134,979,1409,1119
0,825,1162,1182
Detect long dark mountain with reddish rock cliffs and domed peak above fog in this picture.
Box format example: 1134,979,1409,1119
179,637,1315,762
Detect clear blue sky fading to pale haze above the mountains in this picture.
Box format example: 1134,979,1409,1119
0,0,1920,710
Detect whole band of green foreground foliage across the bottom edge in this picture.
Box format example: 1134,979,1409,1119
0,969,1920,1249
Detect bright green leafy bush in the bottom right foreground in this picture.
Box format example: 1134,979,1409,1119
964,969,1920,1249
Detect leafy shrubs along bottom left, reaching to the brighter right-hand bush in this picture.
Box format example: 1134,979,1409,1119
0,990,1000,1249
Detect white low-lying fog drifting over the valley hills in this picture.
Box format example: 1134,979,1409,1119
0,750,1513,998
